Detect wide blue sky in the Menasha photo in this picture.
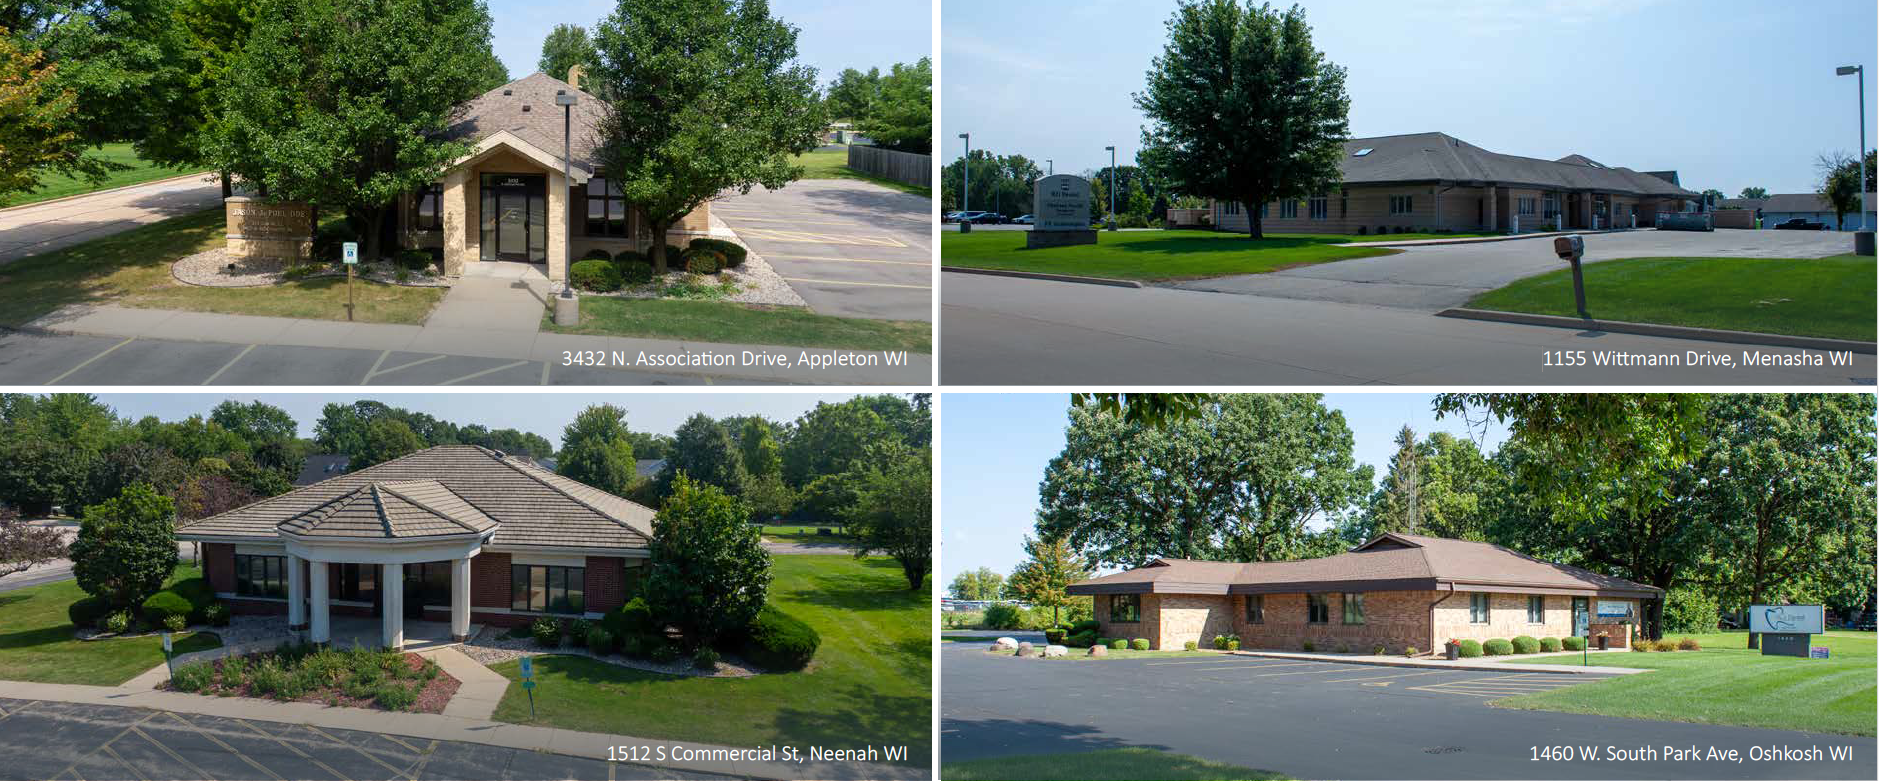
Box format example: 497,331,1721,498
940,0,1879,197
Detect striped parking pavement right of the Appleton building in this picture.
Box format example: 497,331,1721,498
710,178,934,321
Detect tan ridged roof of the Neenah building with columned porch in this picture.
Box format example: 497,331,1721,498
177,445,654,548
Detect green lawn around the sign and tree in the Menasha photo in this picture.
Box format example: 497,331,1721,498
940,231,1398,280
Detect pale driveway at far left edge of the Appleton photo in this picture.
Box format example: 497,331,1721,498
0,175,222,265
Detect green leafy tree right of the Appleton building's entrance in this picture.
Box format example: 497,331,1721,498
594,0,825,274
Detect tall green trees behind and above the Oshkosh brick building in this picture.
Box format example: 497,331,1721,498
1037,394,1875,642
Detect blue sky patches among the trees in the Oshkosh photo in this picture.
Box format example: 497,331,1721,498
934,392,1507,586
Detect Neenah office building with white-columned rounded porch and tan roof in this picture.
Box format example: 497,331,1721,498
177,445,654,648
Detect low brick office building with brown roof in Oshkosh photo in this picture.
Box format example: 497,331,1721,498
1069,533,1663,653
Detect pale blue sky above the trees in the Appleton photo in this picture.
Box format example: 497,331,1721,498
489,0,932,91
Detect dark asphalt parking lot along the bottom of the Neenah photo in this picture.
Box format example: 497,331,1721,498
0,698,722,781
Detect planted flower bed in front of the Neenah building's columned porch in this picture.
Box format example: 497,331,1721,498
162,644,460,713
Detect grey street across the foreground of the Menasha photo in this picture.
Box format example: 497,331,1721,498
940,272,1879,387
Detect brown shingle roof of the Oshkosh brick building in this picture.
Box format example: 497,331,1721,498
1069,533,1659,595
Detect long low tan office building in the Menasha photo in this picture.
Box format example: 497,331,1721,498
1210,133,1702,235
